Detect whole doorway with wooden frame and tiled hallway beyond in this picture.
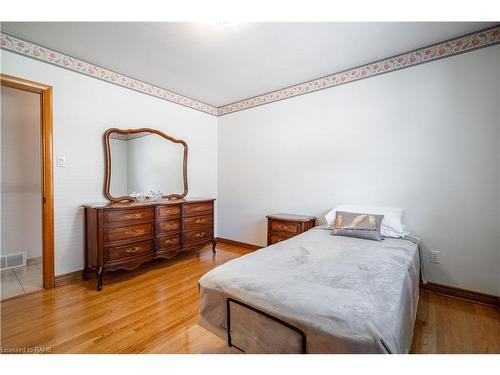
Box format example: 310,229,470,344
0,73,54,300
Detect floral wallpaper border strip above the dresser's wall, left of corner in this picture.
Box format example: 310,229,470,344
0,33,217,116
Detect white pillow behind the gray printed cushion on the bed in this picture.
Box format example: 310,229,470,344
325,204,408,238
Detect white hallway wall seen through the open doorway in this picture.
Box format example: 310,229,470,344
0,86,42,258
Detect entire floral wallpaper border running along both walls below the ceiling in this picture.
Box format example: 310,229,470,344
0,25,500,116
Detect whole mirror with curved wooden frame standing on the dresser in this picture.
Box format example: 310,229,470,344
104,128,188,202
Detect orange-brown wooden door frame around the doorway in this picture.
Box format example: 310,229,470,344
0,73,54,289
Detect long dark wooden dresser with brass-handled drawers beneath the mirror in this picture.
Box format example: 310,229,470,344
83,198,216,291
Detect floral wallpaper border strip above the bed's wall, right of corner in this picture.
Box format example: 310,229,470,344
217,25,500,116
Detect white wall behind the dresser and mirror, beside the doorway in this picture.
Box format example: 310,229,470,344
1,50,217,275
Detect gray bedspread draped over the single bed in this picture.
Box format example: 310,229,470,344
199,229,420,353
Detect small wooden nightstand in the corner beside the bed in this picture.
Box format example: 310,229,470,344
266,214,316,246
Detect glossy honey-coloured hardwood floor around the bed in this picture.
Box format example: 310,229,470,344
0,244,500,353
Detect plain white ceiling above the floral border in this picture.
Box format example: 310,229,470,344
1,22,494,106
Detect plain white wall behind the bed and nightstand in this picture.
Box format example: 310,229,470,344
218,46,500,294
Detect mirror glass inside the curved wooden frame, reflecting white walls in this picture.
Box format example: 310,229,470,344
109,132,184,197
